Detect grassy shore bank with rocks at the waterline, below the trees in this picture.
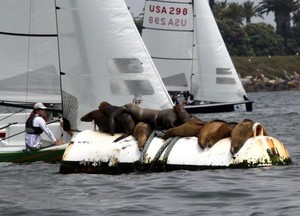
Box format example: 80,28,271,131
231,55,300,92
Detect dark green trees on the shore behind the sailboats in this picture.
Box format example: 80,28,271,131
134,0,300,56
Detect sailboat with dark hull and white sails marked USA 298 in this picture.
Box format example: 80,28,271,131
142,0,253,113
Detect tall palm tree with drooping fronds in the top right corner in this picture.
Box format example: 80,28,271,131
258,0,300,46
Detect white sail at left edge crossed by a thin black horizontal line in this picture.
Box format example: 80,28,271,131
0,0,61,103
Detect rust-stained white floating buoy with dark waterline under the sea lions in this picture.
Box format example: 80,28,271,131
60,130,291,174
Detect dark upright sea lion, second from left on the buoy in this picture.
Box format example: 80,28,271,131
98,101,136,142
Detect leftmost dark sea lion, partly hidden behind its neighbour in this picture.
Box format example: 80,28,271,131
80,110,123,133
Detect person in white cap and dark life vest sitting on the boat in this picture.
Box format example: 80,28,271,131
25,102,63,151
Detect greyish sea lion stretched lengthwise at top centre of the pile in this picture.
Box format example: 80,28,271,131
124,103,177,130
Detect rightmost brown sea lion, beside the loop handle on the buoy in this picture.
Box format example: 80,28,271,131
230,119,269,155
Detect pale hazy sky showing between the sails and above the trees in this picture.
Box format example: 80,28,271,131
125,0,275,25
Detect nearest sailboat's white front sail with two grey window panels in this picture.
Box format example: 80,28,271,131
57,0,172,130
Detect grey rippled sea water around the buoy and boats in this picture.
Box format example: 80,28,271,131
0,91,300,216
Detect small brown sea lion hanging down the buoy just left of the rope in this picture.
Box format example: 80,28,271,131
132,122,153,151
